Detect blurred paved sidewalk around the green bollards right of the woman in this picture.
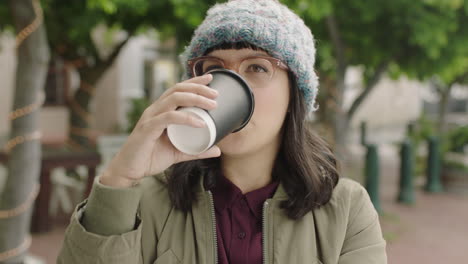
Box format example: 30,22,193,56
348,146,468,264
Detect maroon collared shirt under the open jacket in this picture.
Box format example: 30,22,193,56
211,176,278,264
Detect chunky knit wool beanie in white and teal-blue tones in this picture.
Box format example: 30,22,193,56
180,0,318,112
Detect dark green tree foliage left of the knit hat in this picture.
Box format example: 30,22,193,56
0,0,221,60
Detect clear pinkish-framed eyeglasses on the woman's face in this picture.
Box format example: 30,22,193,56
188,56,288,87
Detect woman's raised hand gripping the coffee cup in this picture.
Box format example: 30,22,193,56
100,74,221,187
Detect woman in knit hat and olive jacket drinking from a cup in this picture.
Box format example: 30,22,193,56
58,0,386,264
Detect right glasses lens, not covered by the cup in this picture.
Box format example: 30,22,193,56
239,58,274,87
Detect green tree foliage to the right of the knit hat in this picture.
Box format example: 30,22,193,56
284,0,468,86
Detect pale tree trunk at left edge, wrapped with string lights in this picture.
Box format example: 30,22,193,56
0,0,50,263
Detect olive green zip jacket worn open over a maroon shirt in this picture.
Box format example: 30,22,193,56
58,173,387,264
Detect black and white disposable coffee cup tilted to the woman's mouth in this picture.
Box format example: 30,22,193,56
167,69,255,155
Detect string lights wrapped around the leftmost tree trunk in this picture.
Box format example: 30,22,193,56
0,0,45,261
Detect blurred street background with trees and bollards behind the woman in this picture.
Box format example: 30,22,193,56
0,0,468,264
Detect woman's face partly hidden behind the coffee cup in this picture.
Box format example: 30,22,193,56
207,49,290,156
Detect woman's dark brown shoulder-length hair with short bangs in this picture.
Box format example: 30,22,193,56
166,42,339,219
